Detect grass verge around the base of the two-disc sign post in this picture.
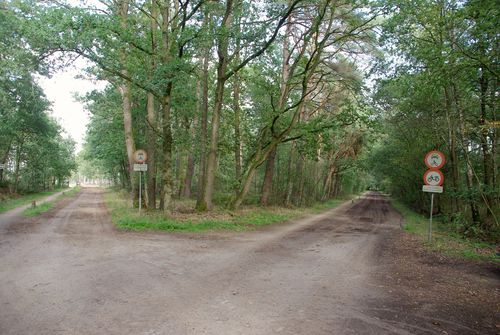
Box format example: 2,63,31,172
392,201,500,263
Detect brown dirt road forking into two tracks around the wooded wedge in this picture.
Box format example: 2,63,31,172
0,189,498,335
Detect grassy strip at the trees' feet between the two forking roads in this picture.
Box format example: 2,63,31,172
104,190,344,232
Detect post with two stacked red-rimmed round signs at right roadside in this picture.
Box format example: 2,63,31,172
422,150,446,243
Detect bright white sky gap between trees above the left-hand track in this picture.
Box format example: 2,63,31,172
38,59,106,152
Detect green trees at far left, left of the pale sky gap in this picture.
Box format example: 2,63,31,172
0,2,76,193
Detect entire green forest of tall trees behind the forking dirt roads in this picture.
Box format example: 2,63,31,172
0,0,500,240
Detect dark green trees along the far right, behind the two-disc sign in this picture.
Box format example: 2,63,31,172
368,1,500,238
